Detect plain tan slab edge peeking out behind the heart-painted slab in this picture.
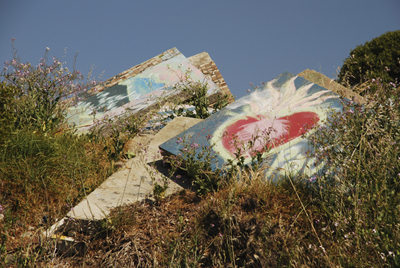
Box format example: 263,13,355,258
298,69,365,104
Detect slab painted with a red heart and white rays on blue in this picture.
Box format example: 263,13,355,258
160,72,342,177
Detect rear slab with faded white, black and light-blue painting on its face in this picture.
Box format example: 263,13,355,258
68,48,220,130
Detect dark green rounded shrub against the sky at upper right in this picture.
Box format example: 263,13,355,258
339,30,400,87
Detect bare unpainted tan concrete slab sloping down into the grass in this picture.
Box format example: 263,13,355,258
67,117,202,220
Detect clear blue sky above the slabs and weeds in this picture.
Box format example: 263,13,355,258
0,0,400,97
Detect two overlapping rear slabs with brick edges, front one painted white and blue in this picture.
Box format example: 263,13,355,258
68,48,232,130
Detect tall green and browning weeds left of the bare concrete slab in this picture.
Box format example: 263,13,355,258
0,40,113,266
